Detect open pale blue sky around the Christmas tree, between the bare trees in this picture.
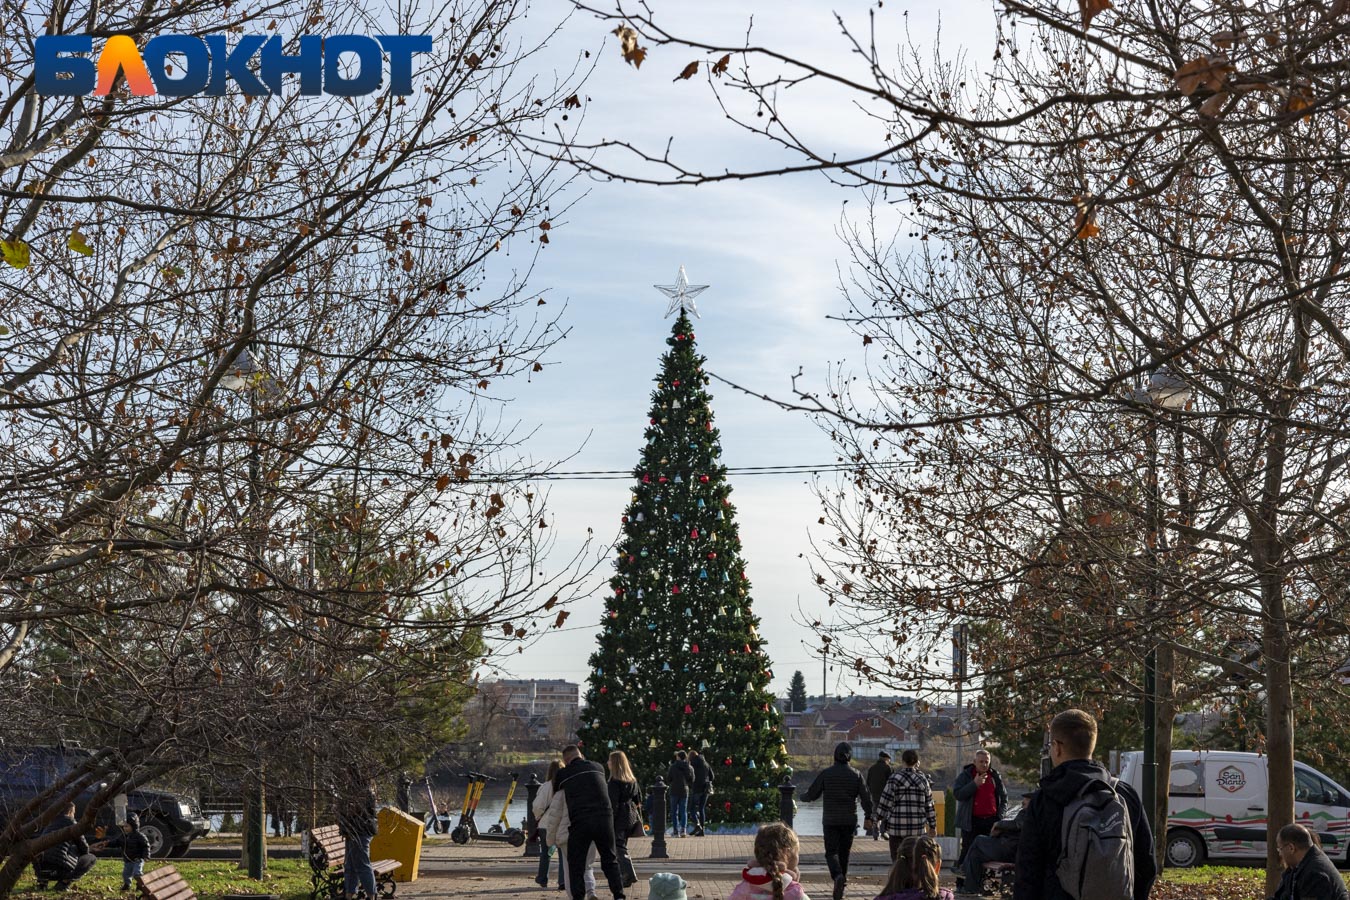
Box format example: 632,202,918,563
480,0,994,692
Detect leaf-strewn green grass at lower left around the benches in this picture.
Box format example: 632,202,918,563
7,860,309,900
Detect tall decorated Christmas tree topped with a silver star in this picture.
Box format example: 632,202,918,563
581,267,787,822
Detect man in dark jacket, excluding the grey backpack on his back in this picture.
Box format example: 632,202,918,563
1013,710,1157,900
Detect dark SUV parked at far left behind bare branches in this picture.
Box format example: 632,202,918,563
0,745,211,857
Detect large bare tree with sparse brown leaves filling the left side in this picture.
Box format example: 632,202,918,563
0,0,596,895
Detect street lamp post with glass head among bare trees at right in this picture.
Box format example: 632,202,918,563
1135,366,1191,846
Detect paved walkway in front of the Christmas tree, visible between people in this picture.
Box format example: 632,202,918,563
398,834,950,900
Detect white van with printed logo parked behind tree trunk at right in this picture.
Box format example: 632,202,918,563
1121,750,1350,868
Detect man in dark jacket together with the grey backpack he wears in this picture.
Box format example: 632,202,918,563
1013,710,1157,900
